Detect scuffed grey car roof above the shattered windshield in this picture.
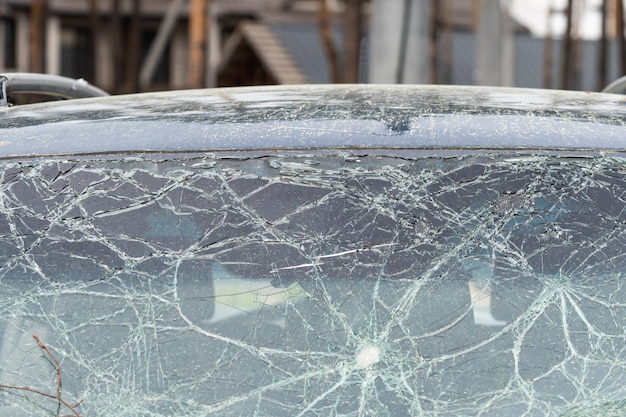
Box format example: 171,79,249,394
0,85,626,157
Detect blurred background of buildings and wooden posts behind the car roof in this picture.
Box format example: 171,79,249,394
0,0,626,93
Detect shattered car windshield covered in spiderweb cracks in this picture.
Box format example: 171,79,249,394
0,151,626,416
